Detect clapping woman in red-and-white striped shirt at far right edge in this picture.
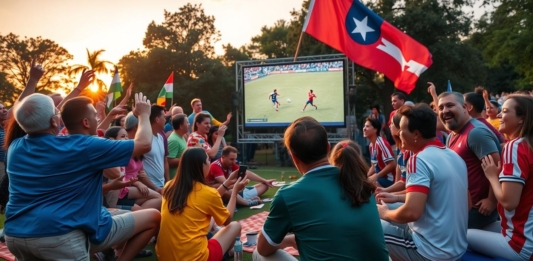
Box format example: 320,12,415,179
468,94,533,260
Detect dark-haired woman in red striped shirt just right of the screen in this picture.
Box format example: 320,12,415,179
363,117,396,188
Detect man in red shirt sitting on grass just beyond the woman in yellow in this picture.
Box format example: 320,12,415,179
206,146,275,206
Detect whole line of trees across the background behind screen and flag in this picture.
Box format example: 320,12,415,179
0,0,533,121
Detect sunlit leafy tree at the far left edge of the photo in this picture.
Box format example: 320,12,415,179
0,33,72,95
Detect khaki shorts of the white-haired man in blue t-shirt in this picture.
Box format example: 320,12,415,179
6,213,135,260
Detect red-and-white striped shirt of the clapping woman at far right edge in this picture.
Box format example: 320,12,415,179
498,138,533,257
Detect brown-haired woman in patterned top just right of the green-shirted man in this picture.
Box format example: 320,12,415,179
187,113,227,158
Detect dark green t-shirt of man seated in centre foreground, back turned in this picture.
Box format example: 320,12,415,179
263,165,389,261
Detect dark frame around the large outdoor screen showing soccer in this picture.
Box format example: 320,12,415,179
240,57,348,130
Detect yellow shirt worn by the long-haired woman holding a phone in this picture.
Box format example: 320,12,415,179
156,182,229,261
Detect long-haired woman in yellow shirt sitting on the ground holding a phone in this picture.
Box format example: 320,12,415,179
156,148,248,261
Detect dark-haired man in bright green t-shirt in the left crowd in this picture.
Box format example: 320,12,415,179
167,113,189,179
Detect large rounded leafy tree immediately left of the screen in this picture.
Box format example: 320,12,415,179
119,4,233,119
